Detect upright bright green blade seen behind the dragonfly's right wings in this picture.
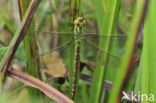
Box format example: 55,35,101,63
90,0,120,103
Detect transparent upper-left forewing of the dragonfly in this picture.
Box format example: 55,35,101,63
27,30,74,54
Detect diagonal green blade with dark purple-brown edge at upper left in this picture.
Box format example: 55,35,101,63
0,0,40,81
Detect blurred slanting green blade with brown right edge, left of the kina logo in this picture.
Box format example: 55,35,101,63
109,0,148,103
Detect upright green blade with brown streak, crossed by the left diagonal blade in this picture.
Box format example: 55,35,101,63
19,0,41,101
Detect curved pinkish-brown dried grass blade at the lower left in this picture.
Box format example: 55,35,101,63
8,69,74,103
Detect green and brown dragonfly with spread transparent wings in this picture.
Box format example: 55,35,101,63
28,17,127,97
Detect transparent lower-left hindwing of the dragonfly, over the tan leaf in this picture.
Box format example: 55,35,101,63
40,41,73,78
